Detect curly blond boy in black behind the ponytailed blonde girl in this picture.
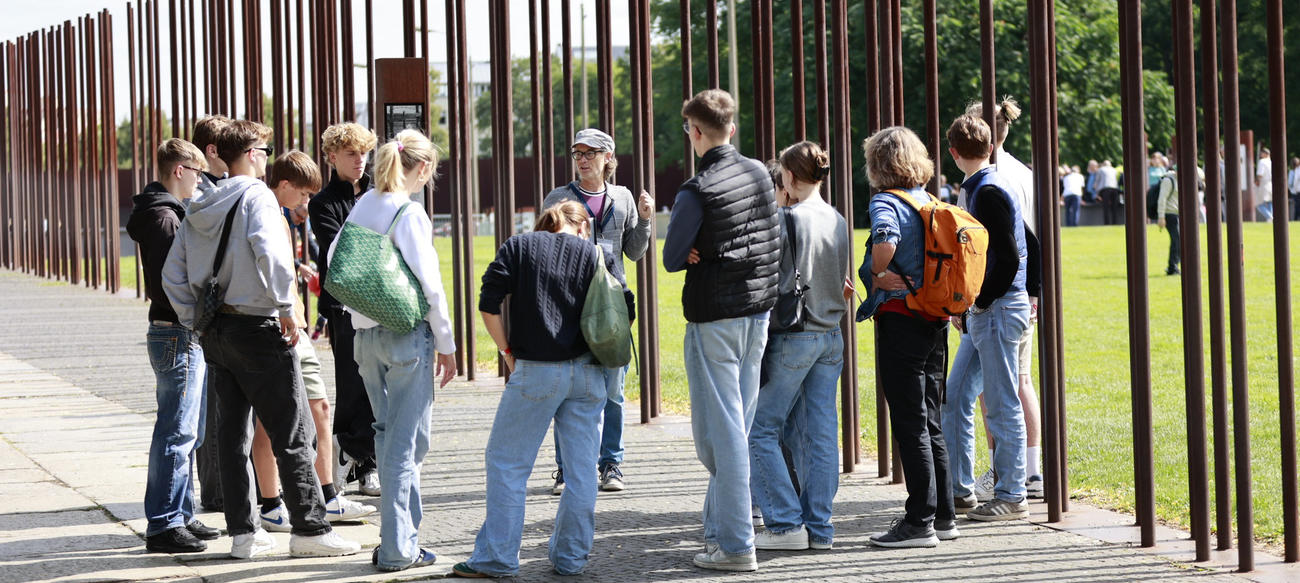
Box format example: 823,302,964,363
307,124,380,496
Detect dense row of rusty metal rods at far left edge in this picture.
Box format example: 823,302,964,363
0,10,121,293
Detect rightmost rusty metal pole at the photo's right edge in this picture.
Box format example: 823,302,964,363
1266,0,1300,562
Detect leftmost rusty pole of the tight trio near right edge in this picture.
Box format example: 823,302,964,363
1174,0,1210,561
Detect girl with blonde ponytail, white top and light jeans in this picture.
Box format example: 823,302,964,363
330,130,456,571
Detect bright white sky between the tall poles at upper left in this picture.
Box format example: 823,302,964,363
0,0,629,124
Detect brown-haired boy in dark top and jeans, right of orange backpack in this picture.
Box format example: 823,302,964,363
941,113,1031,521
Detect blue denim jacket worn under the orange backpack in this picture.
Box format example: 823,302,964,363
857,186,930,321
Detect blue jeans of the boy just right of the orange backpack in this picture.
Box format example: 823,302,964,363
941,292,1030,502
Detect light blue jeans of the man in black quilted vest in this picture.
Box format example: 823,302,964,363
683,312,767,554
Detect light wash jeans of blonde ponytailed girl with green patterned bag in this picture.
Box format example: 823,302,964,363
352,321,436,567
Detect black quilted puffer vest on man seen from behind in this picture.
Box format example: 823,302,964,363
681,144,781,323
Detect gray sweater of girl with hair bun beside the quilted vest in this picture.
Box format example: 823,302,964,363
779,197,852,332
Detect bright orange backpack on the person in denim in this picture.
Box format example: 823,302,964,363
885,189,988,318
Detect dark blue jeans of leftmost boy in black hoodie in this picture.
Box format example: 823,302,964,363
144,324,208,536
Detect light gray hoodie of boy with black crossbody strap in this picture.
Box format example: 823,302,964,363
163,176,295,328
